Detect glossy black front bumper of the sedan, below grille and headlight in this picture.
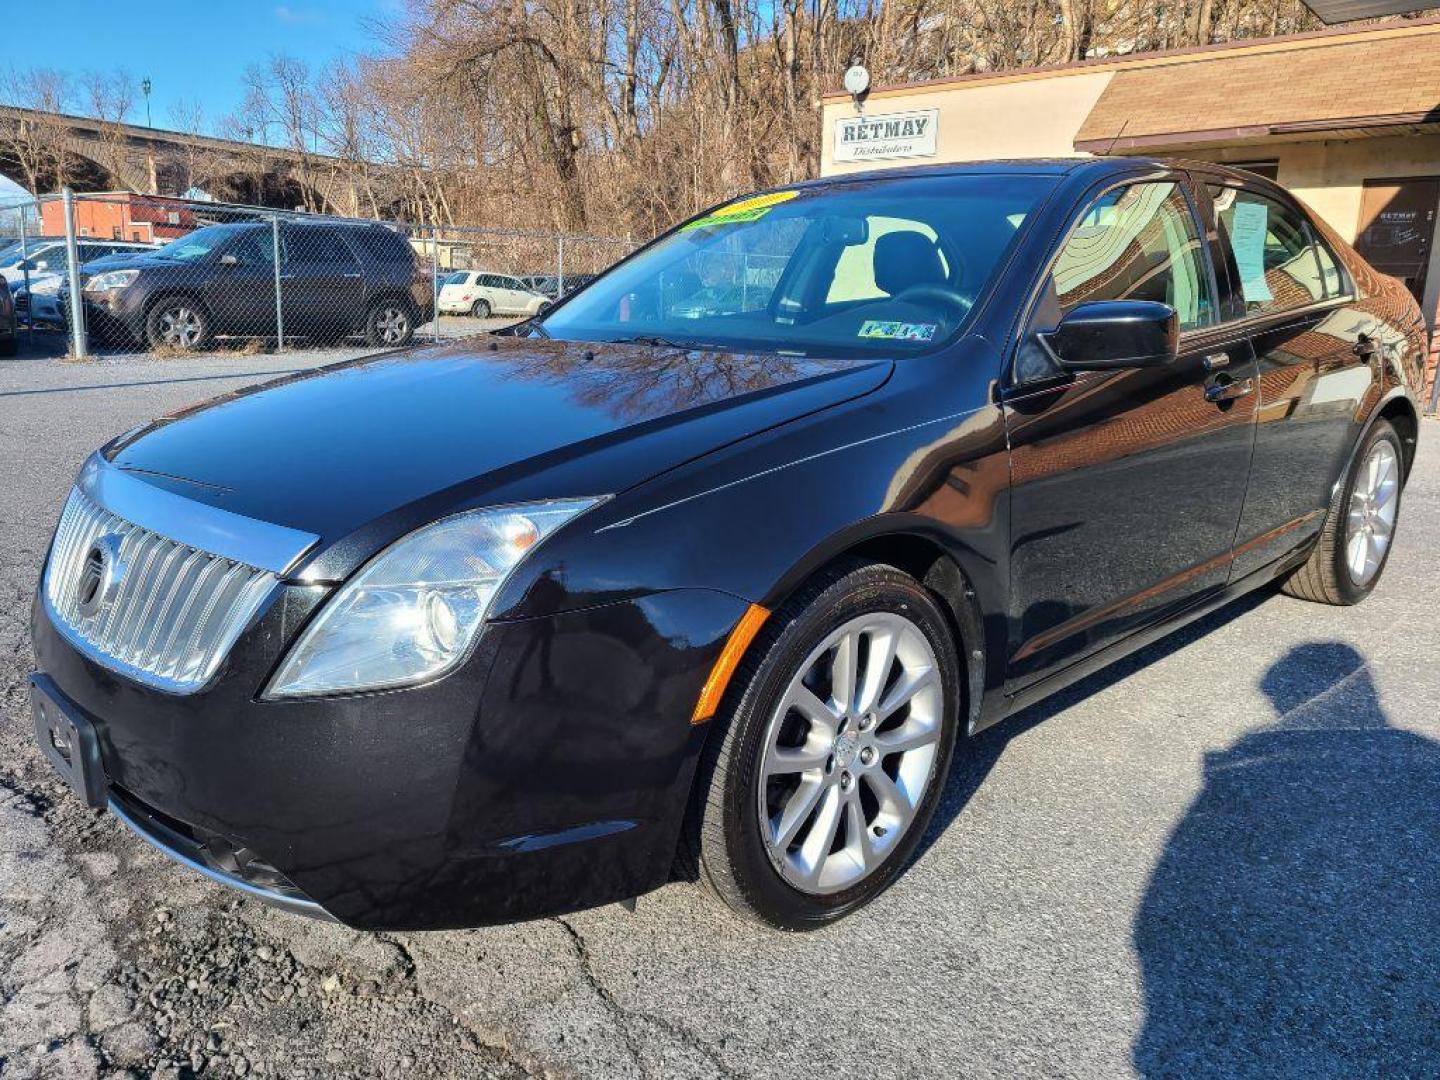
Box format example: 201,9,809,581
32,586,744,929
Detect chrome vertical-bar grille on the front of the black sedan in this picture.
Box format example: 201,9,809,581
45,488,278,694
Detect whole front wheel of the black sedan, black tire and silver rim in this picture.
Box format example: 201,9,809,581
688,562,960,930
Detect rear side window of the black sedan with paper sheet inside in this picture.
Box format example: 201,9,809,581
1210,184,1324,315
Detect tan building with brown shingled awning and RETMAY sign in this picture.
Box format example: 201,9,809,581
821,19,1440,408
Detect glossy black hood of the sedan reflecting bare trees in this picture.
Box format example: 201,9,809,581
105,337,893,558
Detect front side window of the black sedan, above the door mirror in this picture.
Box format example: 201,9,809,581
1051,183,1215,330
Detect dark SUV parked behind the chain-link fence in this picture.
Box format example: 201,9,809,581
71,220,433,348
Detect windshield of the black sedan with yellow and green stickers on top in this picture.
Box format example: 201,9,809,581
540,174,1054,356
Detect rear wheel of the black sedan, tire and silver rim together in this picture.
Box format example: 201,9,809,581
1280,420,1405,606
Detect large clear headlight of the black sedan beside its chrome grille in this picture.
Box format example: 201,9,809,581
265,498,596,698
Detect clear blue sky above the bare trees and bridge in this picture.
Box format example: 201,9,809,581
0,0,400,135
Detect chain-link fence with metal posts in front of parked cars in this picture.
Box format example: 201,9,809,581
0,192,634,357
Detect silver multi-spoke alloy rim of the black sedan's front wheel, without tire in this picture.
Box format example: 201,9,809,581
757,612,945,894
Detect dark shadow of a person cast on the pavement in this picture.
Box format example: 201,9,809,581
1133,642,1440,1077
